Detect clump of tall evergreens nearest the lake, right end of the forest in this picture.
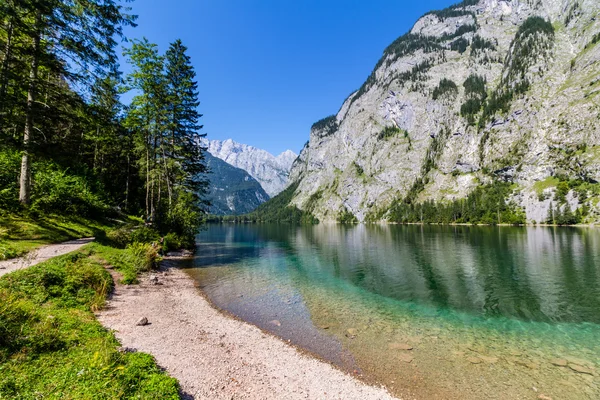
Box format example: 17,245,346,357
125,39,207,237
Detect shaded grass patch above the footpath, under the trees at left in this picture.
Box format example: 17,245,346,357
0,214,114,260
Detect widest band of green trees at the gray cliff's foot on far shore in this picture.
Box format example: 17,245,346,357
388,181,525,225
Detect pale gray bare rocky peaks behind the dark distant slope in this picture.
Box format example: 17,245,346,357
203,139,298,196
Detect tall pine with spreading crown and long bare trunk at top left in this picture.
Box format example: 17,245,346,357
7,0,134,205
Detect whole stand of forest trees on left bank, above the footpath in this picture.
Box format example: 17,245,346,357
0,0,207,250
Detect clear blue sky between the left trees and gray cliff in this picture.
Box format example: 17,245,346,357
123,0,457,154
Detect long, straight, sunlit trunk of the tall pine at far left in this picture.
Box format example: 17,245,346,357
19,11,41,205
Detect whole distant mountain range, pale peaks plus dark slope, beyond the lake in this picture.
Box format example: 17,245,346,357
202,139,297,215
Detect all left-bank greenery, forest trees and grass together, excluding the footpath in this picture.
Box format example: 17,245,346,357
0,0,207,399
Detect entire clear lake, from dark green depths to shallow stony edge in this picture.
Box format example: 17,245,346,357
181,224,600,399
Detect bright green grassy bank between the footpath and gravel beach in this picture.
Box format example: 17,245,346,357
0,245,179,399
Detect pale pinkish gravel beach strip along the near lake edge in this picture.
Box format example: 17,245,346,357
97,261,392,400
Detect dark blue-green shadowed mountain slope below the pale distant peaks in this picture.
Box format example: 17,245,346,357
205,153,269,215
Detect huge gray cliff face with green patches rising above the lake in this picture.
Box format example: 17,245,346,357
290,0,600,222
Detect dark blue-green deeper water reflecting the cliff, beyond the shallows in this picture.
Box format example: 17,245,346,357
195,225,600,323
